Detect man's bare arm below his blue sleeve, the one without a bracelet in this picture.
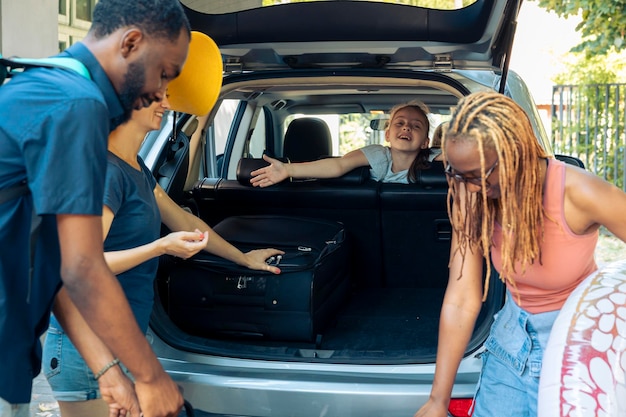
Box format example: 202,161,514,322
57,215,183,417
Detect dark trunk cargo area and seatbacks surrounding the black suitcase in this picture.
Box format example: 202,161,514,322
151,162,504,364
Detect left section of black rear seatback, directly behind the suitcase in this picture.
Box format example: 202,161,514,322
193,160,382,287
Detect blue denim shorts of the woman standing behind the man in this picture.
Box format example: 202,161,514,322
41,320,100,401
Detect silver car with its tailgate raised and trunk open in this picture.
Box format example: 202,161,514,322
141,0,548,417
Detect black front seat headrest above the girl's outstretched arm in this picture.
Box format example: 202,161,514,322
283,117,333,162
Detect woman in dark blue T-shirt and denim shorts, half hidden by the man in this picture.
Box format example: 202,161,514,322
43,97,283,417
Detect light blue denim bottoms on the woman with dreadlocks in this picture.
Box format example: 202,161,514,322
473,291,559,417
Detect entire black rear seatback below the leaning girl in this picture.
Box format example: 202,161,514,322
193,158,450,288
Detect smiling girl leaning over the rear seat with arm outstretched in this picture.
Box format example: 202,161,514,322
250,101,430,187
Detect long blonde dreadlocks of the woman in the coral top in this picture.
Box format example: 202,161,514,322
442,92,548,301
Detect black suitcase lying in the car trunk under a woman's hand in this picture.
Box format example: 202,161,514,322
168,215,350,342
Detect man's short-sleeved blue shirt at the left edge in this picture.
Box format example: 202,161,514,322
0,44,123,403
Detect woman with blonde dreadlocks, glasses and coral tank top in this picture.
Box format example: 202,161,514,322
415,92,626,417
